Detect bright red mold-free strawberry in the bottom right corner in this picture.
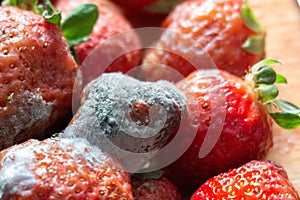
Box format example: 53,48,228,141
191,160,300,200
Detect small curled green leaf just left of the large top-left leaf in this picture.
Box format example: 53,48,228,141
40,0,61,26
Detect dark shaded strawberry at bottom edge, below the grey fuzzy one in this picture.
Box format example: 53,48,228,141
131,177,181,200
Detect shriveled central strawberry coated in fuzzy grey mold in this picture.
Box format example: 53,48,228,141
60,73,186,170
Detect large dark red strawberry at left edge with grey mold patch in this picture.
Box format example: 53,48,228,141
0,6,78,149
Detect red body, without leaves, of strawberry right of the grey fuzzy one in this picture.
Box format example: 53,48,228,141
165,70,272,195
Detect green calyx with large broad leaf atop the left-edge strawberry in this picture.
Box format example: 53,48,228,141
2,0,99,49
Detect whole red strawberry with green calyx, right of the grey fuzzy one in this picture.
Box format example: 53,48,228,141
161,59,300,192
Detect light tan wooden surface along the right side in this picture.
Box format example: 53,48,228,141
248,0,300,192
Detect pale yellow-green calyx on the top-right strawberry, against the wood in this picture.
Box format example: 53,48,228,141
241,1,265,57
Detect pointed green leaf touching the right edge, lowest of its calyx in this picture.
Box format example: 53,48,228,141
270,112,300,129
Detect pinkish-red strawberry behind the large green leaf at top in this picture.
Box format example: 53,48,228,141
56,0,142,85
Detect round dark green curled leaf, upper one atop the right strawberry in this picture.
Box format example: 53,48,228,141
254,66,276,85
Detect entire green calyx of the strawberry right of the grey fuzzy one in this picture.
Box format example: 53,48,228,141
247,59,300,129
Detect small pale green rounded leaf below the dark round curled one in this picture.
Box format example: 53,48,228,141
256,85,279,103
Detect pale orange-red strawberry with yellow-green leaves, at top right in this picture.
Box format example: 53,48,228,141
141,0,265,81
